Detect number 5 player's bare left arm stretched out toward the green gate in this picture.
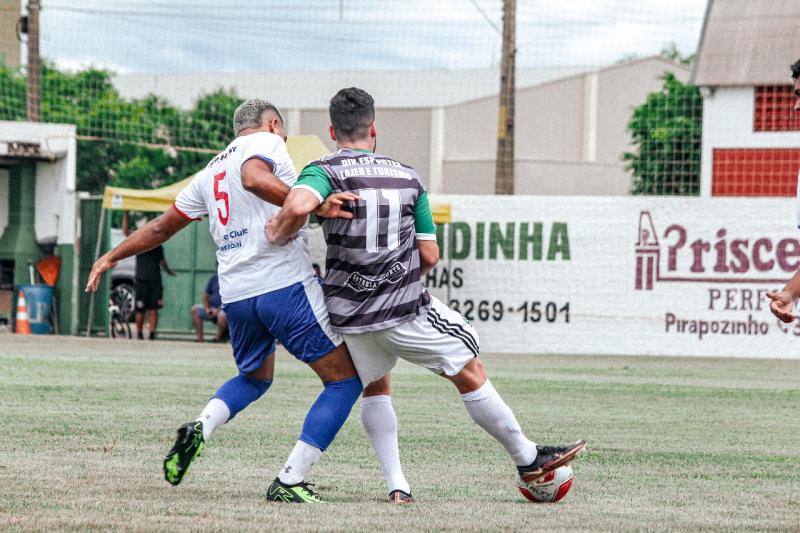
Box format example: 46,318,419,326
86,207,191,292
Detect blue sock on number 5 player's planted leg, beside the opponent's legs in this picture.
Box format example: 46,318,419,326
300,376,362,451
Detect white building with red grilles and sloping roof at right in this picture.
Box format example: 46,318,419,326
692,0,800,196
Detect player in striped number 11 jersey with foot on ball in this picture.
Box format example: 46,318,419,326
266,88,585,503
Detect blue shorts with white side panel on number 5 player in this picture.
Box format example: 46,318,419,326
222,278,342,373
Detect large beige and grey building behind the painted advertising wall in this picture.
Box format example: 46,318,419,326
113,57,690,195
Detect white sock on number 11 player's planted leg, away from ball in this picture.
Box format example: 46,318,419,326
361,395,411,494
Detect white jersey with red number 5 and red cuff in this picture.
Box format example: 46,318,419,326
173,132,314,303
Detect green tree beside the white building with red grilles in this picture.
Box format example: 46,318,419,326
623,72,703,195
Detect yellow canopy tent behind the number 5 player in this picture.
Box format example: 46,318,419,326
103,135,330,212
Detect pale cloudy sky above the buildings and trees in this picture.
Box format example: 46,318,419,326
29,0,706,74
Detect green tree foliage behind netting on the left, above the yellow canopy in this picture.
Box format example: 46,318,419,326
0,64,242,193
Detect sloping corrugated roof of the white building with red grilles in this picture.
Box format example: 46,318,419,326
692,0,800,86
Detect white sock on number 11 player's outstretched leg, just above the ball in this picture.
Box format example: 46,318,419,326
461,379,536,466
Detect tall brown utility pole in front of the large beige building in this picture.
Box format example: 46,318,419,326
494,0,517,194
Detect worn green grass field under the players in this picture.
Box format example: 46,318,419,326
0,335,800,531
